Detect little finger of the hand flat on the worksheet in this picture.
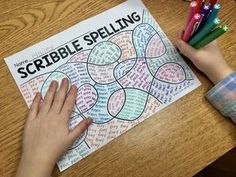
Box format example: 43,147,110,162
28,93,41,120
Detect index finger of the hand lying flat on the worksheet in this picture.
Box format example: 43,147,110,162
61,85,77,118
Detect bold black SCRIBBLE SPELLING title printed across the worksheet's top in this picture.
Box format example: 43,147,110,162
15,12,141,79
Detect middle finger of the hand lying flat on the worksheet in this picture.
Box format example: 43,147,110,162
52,78,69,113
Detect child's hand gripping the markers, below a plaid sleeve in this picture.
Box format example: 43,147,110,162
176,39,233,84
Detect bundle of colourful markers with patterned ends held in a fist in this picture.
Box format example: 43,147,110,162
182,0,229,49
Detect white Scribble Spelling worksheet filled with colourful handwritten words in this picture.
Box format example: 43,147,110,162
5,0,200,171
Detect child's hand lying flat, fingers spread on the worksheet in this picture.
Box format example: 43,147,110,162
17,79,92,177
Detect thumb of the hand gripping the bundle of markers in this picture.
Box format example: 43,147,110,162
176,40,197,60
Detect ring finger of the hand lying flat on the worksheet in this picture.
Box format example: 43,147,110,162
42,81,58,112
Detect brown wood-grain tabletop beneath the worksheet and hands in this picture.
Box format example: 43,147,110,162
0,0,236,177
